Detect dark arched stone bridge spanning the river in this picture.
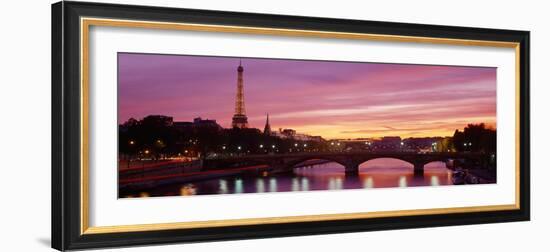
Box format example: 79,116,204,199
203,151,488,174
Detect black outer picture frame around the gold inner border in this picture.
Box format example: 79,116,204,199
51,2,530,251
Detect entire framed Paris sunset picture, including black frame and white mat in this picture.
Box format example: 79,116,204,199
52,2,530,250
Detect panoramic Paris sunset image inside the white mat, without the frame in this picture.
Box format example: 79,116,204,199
117,52,497,198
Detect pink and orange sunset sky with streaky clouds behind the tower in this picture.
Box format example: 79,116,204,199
118,53,496,139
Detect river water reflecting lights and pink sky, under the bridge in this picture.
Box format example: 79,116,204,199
129,158,458,196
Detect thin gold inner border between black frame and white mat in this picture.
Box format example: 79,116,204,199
80,17,520,235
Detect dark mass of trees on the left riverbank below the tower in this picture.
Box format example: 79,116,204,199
119,115,328,159
